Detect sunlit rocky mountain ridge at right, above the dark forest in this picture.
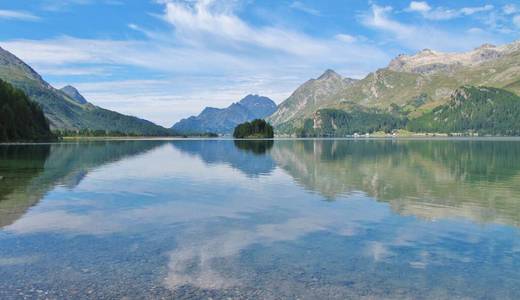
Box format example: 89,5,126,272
270,41,520,134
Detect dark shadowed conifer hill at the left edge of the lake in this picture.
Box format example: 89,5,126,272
0,80,54,142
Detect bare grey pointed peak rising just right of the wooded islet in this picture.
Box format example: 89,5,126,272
269,70,356,125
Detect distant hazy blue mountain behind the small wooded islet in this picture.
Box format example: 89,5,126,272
172,95,276,134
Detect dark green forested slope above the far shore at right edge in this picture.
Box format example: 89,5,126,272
408,87,520,135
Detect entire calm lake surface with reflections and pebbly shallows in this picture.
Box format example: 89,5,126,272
0,140,520,299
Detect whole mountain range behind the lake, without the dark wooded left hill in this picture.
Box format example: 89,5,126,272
0,41,520,136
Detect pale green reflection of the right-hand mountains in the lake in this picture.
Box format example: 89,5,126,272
270,140,520,226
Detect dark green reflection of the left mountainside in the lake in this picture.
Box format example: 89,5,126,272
0,141,164,227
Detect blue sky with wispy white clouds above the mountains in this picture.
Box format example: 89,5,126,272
0,0,520,126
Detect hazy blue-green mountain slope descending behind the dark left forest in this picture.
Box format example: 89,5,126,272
0,48,171,135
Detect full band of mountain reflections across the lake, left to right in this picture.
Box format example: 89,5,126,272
0,140,520,226
